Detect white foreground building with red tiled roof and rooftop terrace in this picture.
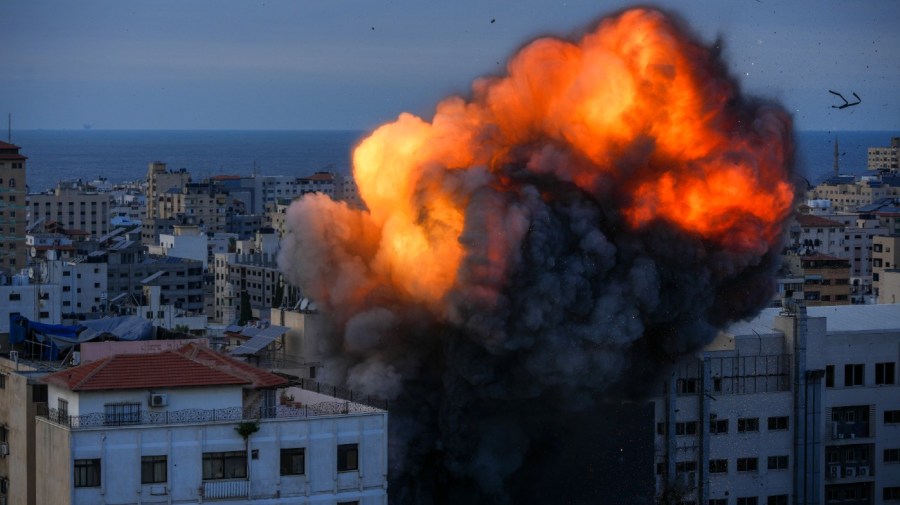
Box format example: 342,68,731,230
35,344,387,505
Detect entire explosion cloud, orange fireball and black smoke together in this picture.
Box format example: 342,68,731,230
279,9,794,503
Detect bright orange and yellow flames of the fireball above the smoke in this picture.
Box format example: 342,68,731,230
353,9,793,307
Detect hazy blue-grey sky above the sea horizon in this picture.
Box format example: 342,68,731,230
0,0,900,131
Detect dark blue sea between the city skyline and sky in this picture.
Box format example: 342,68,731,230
3,129,900,193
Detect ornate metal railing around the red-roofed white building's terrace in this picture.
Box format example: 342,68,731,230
37,401,379,429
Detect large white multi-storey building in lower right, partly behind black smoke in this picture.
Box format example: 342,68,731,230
655,305,900,505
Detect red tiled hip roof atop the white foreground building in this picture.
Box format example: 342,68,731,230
43,344,287,391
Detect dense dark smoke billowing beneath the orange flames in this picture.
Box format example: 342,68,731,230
279,8,790,504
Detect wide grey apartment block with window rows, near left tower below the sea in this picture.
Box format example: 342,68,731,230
28,180,112,237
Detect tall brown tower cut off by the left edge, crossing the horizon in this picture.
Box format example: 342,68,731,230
0,142,28,275
